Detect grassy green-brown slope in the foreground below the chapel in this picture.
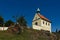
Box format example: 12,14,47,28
0,29,57,40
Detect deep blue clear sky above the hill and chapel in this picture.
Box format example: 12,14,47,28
0,0,60,31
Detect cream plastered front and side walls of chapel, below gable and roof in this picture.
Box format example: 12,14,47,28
32,19,51,32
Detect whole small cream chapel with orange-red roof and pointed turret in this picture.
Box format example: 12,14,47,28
32,8,51,32
